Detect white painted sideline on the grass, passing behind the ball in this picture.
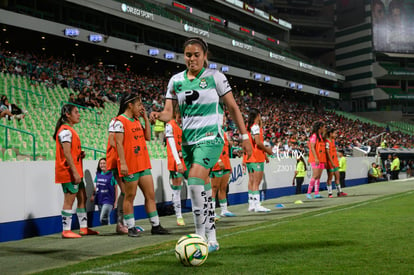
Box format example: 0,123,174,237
71,191,414,275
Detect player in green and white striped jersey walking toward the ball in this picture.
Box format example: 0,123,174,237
151,37,252,254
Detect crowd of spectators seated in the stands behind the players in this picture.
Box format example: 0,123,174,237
0,49,414,160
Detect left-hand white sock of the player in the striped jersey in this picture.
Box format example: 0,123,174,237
188,177,207,238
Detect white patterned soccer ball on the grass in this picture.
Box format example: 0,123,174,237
175,234,208,266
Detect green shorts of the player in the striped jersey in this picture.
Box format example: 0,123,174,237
182,142,224,169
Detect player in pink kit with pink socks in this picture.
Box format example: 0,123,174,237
306,121,326,199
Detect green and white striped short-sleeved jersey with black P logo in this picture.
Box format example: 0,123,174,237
166,68,231,145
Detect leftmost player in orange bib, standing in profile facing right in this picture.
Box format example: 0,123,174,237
53,104,98,238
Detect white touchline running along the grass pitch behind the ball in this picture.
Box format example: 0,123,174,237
68,191,414,274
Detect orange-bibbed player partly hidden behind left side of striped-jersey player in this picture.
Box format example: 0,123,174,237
165,106,187,226
